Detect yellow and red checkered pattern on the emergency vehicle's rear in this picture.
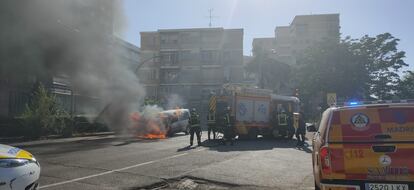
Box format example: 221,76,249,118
324,106,414,181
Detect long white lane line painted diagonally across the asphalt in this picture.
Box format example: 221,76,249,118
39,153,188,189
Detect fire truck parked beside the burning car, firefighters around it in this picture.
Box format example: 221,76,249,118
208,85,300,139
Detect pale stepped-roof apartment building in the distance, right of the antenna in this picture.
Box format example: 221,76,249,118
253,14,340,65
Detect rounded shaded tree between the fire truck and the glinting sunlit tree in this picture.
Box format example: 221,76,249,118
295,38,369,117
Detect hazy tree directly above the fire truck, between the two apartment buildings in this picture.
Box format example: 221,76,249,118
245,48,293,93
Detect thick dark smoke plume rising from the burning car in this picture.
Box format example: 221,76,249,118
0,0,145,131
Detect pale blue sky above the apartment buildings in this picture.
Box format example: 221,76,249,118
120,0,414,70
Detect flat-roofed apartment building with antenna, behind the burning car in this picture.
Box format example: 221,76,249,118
138,28,244,108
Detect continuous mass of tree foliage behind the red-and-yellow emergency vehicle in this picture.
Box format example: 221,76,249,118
295,33,414,119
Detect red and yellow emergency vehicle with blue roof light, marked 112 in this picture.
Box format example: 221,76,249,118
312,102,414,190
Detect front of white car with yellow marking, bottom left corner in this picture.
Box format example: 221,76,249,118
0,144,40,190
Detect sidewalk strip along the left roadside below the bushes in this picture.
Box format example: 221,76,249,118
0,132,115,147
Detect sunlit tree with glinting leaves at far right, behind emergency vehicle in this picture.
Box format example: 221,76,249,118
350,33,408,99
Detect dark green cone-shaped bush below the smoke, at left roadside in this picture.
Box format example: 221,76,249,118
22,84,69,138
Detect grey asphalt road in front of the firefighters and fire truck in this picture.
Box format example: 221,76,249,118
20,132,313,190
